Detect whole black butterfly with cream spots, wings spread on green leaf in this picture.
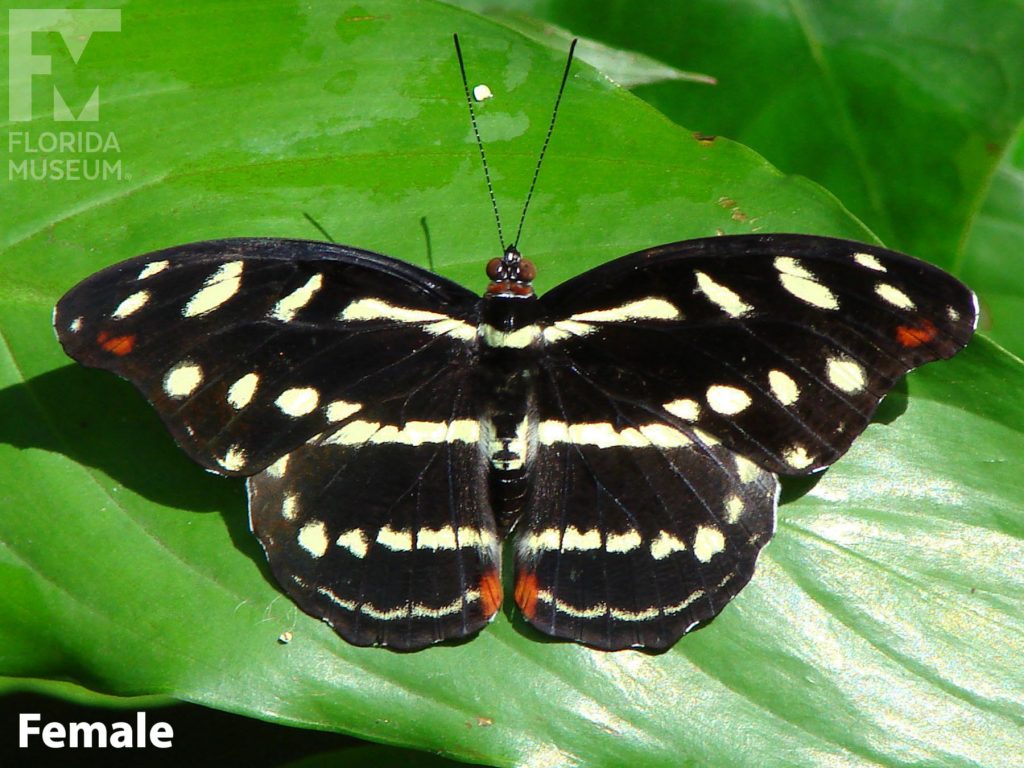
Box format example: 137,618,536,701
54,37,977,650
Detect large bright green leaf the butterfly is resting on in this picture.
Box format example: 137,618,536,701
0,1,1024,766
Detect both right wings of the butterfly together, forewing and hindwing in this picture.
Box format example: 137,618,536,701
515,234,977,649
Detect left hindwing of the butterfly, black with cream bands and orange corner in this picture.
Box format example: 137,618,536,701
249,371,502,650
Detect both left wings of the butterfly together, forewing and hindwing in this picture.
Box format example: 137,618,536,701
54,240,501,648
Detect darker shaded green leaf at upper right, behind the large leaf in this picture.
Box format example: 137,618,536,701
459,0,1024,267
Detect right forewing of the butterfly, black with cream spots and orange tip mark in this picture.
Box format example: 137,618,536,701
541,234,977,474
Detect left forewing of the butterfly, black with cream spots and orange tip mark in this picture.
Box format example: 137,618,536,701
54,239,477,475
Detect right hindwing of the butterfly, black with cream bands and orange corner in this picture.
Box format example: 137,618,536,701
514,367,777,650
